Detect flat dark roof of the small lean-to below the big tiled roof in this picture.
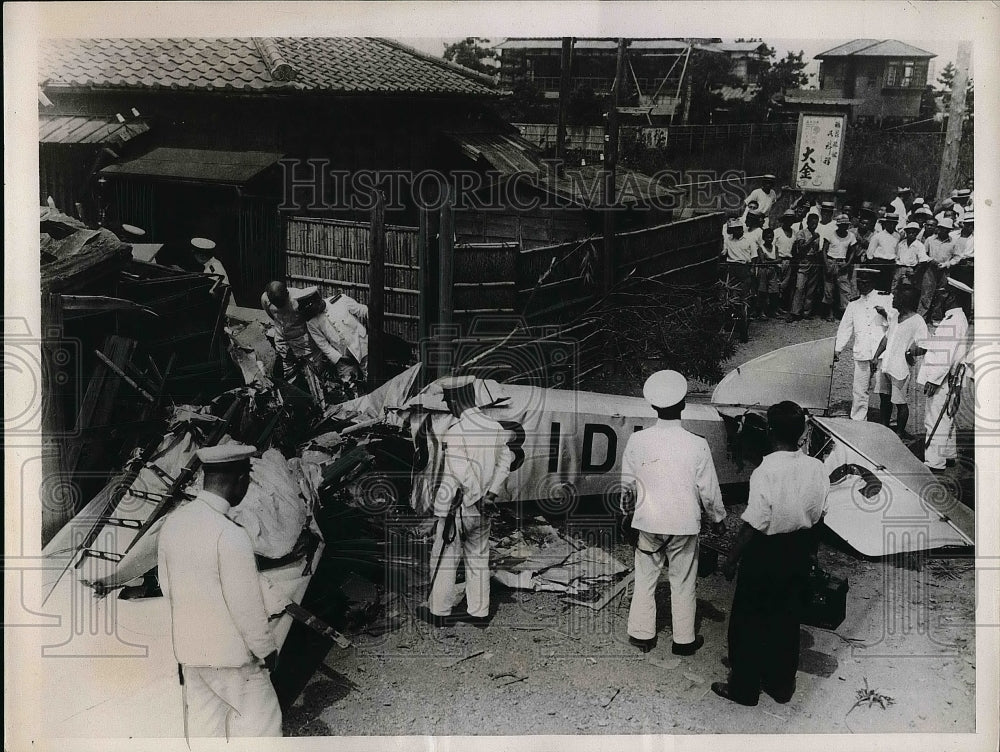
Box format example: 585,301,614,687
101,147,282,185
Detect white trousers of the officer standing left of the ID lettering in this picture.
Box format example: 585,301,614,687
428,505,490,616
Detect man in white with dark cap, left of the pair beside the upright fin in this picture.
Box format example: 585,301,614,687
833,267,892,420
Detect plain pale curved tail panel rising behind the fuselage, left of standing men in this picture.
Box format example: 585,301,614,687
712,337,834,412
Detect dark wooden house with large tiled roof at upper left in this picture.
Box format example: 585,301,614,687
39,38,517,305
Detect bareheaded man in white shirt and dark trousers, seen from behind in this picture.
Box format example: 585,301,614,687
712,401,830,705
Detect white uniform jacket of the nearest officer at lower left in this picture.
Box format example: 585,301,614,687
157,491,278,668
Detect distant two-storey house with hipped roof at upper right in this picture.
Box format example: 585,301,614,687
785,39,936,124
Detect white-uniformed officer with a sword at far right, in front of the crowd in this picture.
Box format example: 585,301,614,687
916,278,972,471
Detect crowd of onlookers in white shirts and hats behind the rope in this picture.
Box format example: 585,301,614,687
723,175,975,328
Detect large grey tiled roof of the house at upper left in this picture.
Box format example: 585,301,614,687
39,37,498,96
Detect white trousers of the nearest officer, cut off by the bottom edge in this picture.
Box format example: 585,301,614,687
182,663,281,739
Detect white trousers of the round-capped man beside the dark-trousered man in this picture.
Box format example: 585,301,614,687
628,531,698,644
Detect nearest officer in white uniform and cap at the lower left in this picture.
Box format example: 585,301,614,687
157,443,281,737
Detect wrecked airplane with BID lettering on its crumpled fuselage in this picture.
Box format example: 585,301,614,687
40,339,975,737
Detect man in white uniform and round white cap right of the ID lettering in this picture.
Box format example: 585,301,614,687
622,371,726,655
